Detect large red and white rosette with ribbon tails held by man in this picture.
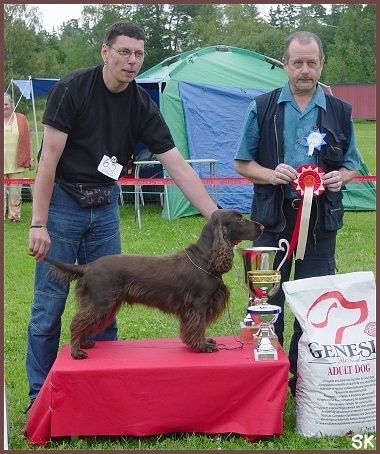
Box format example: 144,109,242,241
288,164,325,260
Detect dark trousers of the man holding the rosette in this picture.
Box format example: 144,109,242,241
253,201,337,376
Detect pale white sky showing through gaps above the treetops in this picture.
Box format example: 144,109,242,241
33,3,272,33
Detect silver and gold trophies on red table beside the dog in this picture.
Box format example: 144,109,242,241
239,239,289,360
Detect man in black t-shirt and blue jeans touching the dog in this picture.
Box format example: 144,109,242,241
26,21,217,408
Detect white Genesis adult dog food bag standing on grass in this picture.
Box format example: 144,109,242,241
283,271,376,437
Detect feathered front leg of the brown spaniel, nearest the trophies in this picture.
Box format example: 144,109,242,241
180,307,218,353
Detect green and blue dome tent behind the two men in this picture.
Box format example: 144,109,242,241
136,46,376,219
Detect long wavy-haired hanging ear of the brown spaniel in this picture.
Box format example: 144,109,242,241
208,223,234,274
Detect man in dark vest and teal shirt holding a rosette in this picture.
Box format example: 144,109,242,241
235,31,360,395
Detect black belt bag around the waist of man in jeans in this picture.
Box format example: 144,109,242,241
56,179,115,208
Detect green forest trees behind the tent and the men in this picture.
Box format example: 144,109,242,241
4,3,376,114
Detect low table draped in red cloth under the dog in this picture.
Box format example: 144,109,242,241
25,337,289,445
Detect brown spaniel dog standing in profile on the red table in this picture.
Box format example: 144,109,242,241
46,209,263,359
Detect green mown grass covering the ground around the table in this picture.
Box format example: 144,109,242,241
4,123,376,451
